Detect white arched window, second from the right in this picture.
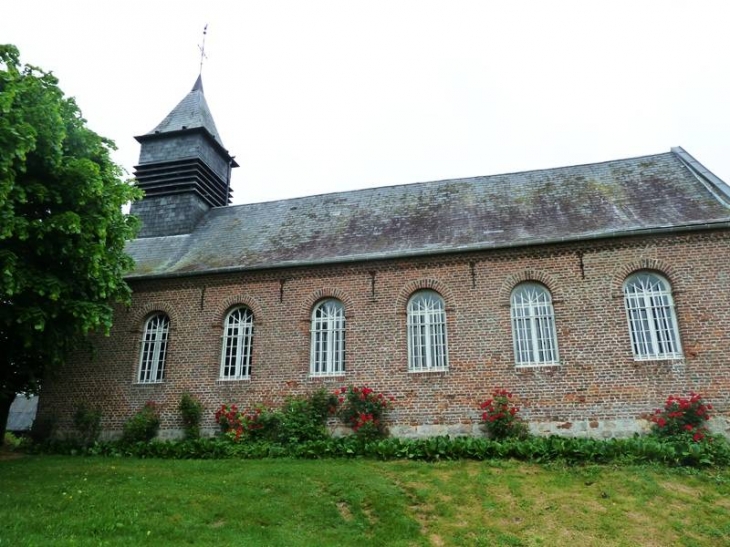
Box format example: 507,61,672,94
511,283,559,366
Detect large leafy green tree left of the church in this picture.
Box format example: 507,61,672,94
0,45,138,439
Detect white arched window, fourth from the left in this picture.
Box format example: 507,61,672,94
408,291,449,372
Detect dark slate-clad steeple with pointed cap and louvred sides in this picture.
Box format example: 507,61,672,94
131,76,238,237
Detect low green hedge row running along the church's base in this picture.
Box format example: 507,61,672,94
35,436,730,467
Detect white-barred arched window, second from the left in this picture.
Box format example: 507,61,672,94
220,307,253,380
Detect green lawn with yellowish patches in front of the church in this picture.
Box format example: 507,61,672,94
0,456,730,547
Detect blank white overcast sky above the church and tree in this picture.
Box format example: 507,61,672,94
0,0,730,203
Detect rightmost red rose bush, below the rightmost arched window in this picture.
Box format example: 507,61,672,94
651,393,712,442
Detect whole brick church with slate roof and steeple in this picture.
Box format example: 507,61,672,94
40,78,730,437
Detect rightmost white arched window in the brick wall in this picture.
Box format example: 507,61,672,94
624,272,682,360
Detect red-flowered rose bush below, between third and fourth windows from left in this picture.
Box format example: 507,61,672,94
336,386,393,440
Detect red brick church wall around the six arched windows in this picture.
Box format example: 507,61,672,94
41,232,730,438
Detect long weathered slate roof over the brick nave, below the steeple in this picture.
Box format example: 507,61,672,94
127,148,730,279
